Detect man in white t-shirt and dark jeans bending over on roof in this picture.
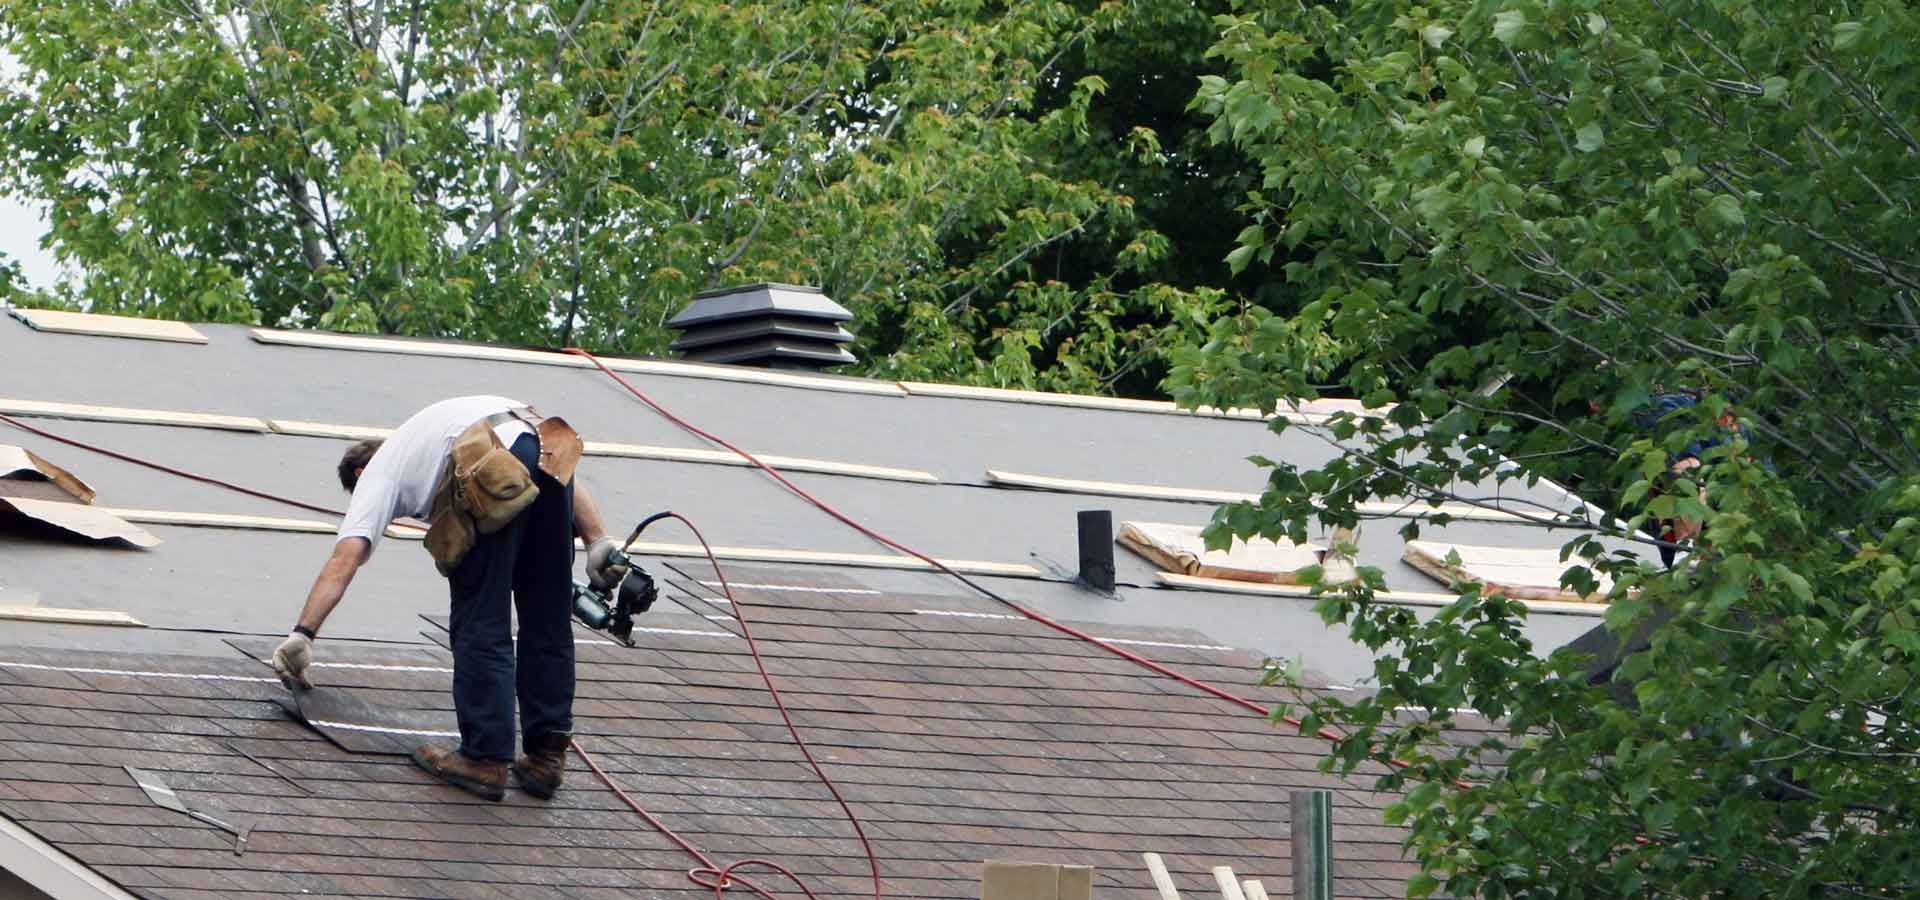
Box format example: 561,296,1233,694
273,397,626,800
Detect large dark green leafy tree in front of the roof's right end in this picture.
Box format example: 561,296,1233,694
1173,0,1920,898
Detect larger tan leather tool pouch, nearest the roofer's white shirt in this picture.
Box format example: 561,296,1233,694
426,420,541,576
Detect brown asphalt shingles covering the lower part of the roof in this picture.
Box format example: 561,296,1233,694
0,570,1443,900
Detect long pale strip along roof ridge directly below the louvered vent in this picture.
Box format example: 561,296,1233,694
252,328,906,397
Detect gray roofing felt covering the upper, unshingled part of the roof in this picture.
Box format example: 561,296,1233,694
0,319,1594,679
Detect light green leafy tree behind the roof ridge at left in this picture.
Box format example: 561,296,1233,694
0,0,1217,386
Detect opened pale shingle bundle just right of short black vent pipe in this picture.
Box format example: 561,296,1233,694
1119,522,1354,585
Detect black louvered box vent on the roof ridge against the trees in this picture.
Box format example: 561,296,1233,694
666,284,856,370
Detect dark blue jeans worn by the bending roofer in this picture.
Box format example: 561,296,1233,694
447,434,574,760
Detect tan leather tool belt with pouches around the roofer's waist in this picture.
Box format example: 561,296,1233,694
426,407,584,576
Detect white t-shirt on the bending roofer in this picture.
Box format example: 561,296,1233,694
340,395,534,547
